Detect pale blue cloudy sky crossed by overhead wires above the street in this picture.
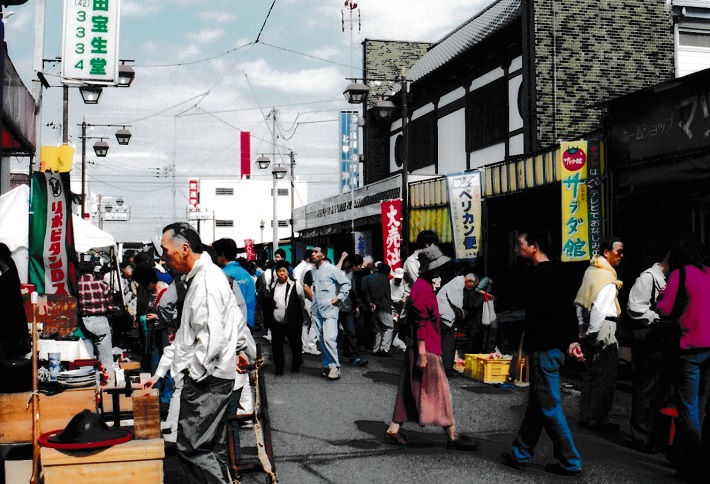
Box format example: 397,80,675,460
5,0,492,242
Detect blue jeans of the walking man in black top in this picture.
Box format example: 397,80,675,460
513,348,582,471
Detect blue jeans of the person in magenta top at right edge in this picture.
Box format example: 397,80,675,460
675,348,710,475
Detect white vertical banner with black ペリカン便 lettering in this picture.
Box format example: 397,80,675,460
446,171,482,259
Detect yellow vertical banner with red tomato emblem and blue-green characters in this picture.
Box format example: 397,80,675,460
557,140,591,262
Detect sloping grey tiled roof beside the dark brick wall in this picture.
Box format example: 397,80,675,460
407,0,521,81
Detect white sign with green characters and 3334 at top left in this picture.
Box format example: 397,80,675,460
62,0,121,84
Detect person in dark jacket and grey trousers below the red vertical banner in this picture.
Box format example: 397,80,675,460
363,262,394,356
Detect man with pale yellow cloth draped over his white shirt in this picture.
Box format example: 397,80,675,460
574,237,624,431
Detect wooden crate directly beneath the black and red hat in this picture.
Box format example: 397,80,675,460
40,439,165,484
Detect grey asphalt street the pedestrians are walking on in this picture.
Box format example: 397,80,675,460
165,344,679,484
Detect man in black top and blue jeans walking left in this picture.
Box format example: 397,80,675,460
502,229,583,476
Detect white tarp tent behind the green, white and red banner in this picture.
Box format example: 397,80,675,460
0,185,115,283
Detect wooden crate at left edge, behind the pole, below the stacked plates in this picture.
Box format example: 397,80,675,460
0,387,96,444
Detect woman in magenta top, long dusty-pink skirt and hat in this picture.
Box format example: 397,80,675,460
385,245,479,450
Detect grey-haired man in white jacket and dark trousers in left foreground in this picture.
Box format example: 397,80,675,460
158,223,248,483
